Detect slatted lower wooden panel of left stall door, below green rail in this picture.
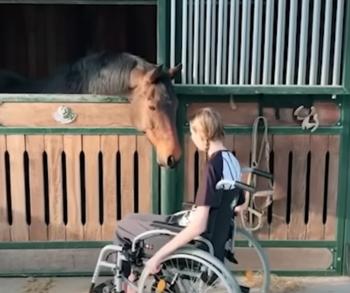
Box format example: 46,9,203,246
0,135,152,241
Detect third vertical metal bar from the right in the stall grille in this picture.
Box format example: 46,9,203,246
309,0,321,85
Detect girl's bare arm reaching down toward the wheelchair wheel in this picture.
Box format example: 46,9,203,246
151,206,209,262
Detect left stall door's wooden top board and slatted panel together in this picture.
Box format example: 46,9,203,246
0,102,152,242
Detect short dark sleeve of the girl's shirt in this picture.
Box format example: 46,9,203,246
195,164,221,208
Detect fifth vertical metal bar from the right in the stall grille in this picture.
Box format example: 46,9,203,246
286,1,298,85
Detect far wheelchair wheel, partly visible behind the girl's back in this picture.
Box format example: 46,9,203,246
233,227,271,293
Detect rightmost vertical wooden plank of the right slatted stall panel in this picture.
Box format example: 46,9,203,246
324,135,340,240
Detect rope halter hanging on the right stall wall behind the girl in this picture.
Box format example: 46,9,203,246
241,116,273,231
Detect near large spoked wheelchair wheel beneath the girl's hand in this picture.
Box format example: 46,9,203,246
138,248,241,293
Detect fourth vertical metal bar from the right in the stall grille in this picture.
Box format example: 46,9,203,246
298,0,309,85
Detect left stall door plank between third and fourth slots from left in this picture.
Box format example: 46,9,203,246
44,135,66,240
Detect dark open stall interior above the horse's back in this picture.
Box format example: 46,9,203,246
0,4,157,78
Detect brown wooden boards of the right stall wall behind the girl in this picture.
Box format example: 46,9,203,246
184,102,340,241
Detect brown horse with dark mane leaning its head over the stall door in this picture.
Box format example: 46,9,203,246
0,52,181,167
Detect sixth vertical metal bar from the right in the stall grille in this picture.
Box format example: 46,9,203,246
274,0,286,84
